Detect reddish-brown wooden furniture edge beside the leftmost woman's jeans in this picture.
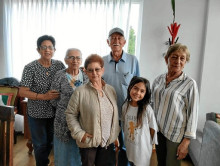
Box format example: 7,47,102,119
21,99,33,154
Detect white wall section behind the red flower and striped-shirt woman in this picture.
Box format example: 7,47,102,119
140,0,206,86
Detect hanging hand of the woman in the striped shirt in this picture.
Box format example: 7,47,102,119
176,138,190,160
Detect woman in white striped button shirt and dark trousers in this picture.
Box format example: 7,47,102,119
152,44,199,166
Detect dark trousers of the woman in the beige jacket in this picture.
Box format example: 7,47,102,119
79,143,116,166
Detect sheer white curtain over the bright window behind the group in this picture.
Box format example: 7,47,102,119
3,0,142,79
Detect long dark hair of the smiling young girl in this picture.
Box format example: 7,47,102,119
125,76,151,127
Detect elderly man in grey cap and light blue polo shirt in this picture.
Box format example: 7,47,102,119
103,27,140,166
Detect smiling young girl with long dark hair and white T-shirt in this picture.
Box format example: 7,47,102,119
122,76,157,166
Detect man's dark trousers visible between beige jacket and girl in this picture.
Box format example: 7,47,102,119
118,121,129,166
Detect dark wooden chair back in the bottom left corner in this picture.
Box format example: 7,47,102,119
0,106,15,166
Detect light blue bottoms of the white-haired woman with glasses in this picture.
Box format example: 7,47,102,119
54,135,81,166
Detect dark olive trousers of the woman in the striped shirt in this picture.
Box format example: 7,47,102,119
156,132,181,166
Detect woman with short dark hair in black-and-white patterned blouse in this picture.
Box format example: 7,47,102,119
19,35,65,166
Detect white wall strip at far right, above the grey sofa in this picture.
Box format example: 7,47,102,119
199,0,220,130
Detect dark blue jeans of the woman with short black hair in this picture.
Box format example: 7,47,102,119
28,116,54,166
